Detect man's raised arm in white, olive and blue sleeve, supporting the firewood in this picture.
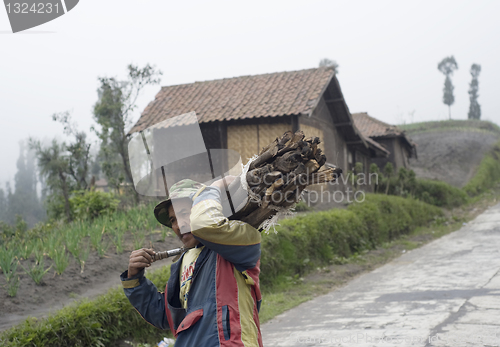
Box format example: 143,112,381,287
191,186,261,271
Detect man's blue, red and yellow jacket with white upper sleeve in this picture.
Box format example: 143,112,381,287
120,187,262,347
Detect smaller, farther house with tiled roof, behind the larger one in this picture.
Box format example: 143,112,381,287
352,112,417,170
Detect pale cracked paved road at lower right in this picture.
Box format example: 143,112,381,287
262,204,500,347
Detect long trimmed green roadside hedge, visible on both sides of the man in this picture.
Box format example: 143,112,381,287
0,194,442,347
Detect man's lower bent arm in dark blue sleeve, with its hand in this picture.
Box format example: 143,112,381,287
120,248,169,329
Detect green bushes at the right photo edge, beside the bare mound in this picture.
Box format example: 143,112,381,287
463,142,500,196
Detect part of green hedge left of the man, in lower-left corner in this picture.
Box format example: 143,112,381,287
0,266,170,347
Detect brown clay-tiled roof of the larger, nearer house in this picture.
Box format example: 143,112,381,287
130,68,334,133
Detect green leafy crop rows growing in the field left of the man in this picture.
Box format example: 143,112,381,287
0,202,161,293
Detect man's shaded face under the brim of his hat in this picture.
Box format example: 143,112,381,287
168,199,200,248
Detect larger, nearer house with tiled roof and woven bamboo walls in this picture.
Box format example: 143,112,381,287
129,68,389,185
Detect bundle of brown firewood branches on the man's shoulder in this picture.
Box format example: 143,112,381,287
229,131,342,228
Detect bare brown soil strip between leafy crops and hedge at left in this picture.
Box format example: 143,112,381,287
0,236,182,331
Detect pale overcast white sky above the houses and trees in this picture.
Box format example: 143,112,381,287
0,0,500,187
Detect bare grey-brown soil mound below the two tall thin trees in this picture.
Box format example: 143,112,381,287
409,130,498,188
